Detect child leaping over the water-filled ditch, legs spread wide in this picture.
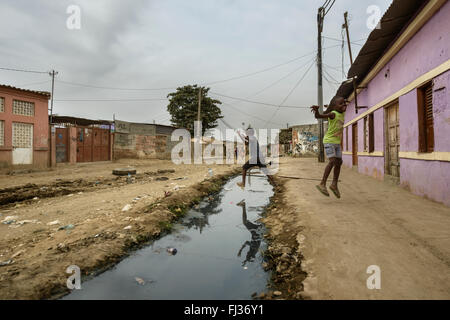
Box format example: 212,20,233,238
237,128,275,189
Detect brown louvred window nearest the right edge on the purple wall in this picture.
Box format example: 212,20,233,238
417,82,434,152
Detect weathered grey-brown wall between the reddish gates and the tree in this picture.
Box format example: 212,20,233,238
114,121,177,159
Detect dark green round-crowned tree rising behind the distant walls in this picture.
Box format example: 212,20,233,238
167,85,223,135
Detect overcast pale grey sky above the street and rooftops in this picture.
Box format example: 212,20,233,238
0,0,391,128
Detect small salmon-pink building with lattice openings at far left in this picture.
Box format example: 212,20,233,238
0,85,50,167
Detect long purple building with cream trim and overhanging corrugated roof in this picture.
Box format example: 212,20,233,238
337,0,450,206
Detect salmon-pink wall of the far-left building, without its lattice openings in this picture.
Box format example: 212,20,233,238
0,87,50,168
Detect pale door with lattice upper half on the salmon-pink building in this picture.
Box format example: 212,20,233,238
12,122,33,164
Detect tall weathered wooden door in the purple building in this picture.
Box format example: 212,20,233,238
385,102,400,177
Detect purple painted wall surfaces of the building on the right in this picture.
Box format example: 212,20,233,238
343,1,450,205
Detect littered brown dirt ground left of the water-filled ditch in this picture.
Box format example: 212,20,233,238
0,160,236,299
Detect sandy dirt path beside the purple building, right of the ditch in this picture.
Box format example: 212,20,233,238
264,158,450,299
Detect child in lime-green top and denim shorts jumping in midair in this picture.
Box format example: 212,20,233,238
311,96,347,198
